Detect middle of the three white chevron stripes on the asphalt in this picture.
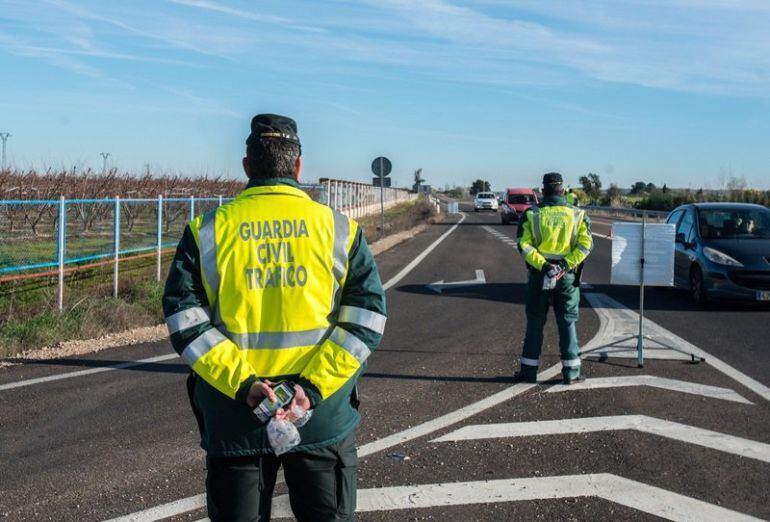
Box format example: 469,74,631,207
431,415,770,462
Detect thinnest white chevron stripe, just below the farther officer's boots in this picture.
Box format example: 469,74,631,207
546,375,754,404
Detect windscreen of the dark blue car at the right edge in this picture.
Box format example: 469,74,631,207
698,208,770,239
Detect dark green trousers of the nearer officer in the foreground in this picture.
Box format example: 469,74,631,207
206,433,358,522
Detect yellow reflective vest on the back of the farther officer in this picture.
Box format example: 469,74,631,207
528,205,583,261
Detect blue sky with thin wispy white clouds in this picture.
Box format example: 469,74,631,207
0,0,770,189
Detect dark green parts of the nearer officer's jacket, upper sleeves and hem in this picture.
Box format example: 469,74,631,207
163,178,386,456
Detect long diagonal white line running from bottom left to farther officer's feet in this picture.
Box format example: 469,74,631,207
100,363,561,522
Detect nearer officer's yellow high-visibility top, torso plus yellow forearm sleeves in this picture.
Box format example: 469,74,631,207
183,185,376,398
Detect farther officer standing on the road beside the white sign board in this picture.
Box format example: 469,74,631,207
514,172,593,384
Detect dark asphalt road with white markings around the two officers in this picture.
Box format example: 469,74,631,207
0,205,770,521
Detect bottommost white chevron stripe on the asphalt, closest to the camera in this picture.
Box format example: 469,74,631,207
273,473,760,522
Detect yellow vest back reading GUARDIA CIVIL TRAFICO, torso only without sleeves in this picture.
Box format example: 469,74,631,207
190,185,358,377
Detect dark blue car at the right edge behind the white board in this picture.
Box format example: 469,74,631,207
666,203,770,305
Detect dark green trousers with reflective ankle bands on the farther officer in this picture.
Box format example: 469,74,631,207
521,271,580,378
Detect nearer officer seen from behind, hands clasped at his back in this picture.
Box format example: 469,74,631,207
163,114,385,522
